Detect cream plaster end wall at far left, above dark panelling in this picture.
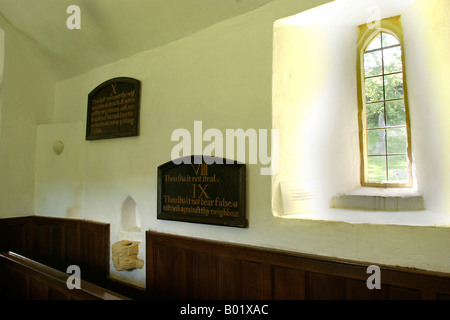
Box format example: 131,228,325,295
0,16,57,217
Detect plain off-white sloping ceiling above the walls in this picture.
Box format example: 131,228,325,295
0,0,273,79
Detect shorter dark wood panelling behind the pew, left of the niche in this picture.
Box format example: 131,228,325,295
0,216,110,285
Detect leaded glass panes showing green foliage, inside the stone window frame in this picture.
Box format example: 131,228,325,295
364,32,409,183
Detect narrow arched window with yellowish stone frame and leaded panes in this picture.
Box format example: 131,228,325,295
359,19,412,187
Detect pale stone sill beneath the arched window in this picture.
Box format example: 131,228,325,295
330,187,424,211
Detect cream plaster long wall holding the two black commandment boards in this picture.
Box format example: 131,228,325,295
29,1,450,285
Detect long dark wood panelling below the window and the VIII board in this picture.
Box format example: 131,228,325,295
146,231,450,300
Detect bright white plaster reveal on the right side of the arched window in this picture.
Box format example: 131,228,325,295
402,0,450,212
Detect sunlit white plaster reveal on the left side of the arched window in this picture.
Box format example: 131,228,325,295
273,23,359,215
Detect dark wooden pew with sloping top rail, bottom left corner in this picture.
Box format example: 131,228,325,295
0,252,129,300
